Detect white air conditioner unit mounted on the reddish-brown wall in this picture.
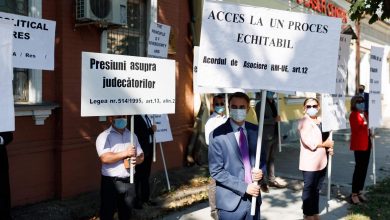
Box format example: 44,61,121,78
76,0,127,25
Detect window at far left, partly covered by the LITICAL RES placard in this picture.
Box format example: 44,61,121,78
0,0,29,102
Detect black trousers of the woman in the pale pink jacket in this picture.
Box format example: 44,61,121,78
302,167,326,216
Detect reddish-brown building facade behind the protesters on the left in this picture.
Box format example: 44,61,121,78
0,0,194,206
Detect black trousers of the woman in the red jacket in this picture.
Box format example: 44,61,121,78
352,149,371,193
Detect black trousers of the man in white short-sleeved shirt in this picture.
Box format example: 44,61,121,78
100,176,134,220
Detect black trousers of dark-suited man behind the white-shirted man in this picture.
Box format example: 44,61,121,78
134,153,153,204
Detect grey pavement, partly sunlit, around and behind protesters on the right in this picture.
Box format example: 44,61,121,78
163,128,390,220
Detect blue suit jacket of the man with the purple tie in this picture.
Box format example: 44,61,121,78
209,119,266,211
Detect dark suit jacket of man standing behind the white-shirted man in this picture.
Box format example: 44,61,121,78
134,115,154,156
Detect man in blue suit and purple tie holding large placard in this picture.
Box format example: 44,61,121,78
209,92,266,220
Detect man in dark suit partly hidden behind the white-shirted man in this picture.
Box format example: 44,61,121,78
134,115,157,209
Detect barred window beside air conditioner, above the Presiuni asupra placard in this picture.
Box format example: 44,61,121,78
107,0,147,56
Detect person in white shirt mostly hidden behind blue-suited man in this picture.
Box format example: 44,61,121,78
204,95,227,219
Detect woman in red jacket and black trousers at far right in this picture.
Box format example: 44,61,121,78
349,95,371,204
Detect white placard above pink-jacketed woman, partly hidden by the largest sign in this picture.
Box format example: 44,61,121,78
321,34,351,132
